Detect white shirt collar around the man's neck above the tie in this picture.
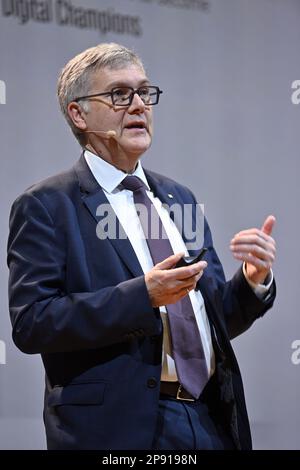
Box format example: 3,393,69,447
84,150,150,193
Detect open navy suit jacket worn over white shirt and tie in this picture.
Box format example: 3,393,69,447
8,156,275,449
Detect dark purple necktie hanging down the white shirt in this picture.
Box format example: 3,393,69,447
122,176,208,398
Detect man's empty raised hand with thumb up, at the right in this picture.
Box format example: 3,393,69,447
230,215,276,284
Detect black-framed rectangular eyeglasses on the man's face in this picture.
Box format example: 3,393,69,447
73,85,162,106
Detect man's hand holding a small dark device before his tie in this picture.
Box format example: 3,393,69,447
145,253,207,307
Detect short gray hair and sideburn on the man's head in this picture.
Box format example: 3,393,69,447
57,43,144,145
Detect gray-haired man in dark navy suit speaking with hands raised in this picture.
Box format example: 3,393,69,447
8,44,275,449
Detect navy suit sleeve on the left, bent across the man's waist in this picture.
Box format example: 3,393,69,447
8,193,162,353
